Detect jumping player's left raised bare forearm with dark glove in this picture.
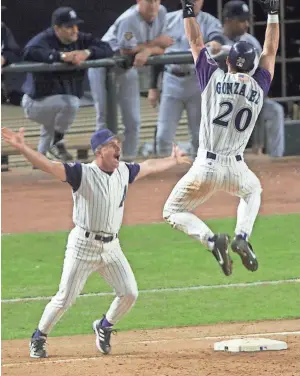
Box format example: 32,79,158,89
181,0,205,64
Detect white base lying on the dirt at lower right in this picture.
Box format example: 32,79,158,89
214,338,288,352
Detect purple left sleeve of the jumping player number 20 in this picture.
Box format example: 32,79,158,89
196,48,219,92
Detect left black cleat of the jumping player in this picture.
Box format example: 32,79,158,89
212,234,232,276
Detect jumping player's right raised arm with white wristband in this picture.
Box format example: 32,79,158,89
258,0,280,79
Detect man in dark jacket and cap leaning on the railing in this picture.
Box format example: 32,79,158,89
22,7,113,161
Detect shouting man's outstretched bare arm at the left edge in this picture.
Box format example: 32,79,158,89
1,128,66,181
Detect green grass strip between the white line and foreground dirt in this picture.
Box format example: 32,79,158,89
2,283,299,339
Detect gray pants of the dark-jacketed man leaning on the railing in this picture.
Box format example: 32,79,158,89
22,94,80,154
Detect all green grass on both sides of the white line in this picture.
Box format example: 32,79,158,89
2,214,300,339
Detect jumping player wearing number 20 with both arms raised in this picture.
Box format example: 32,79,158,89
163,0,279,276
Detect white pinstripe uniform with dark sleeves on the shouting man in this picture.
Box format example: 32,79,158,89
39,162,140,334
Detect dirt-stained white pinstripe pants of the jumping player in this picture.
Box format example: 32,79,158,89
163,150,262,246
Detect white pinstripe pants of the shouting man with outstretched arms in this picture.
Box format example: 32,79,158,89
38,227,138,334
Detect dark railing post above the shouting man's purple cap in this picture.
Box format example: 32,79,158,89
106,67,118,134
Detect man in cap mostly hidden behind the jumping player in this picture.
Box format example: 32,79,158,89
218,0,285,157
